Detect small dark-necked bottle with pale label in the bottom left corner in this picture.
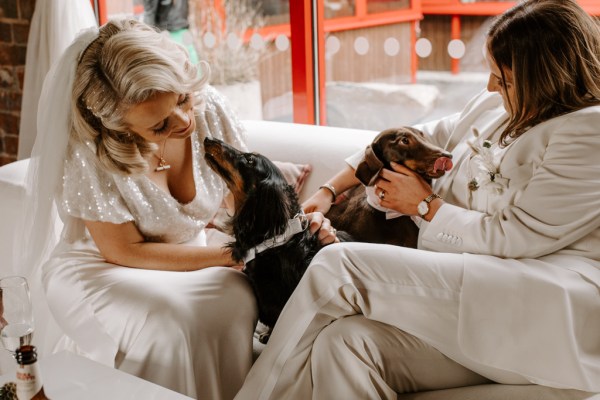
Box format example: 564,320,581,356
15,345,49,400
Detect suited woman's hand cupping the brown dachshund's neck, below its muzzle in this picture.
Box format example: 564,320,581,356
375,162,432,215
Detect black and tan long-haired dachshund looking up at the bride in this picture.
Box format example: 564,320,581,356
204,138,322,341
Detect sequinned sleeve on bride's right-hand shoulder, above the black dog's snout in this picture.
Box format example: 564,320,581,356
197,86,248,151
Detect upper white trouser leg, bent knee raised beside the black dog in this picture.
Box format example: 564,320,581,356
237,243,528,400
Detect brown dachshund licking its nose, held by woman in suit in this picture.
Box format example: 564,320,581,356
326,127,452,248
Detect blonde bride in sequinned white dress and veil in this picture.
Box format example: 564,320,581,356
16,20,334,399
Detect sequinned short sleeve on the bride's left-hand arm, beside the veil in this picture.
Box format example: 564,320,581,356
58,144,134,224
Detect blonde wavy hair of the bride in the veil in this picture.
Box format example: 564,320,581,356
71,19,209,174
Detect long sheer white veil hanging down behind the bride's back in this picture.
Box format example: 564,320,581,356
13,27,98,368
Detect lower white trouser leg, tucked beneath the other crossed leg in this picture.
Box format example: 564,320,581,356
311,315,489,400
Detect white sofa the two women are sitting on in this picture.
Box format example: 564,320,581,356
0,121,600,400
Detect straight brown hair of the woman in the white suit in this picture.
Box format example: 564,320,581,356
487,0,600,146
